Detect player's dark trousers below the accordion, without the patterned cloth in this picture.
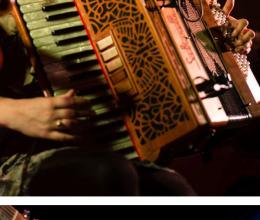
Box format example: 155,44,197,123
28,151,196,196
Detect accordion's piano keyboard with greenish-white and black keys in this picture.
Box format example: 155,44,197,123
17,0,138,159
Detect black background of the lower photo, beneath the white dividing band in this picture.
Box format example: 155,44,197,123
11,206,260,220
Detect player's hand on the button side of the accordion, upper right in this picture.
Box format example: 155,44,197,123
223,0,255,54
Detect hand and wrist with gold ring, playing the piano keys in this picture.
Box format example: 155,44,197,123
0,90,93,141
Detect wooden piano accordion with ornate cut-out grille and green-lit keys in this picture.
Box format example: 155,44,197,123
12,0,260,161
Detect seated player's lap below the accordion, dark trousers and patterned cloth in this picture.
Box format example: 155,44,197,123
0,147,195,196
